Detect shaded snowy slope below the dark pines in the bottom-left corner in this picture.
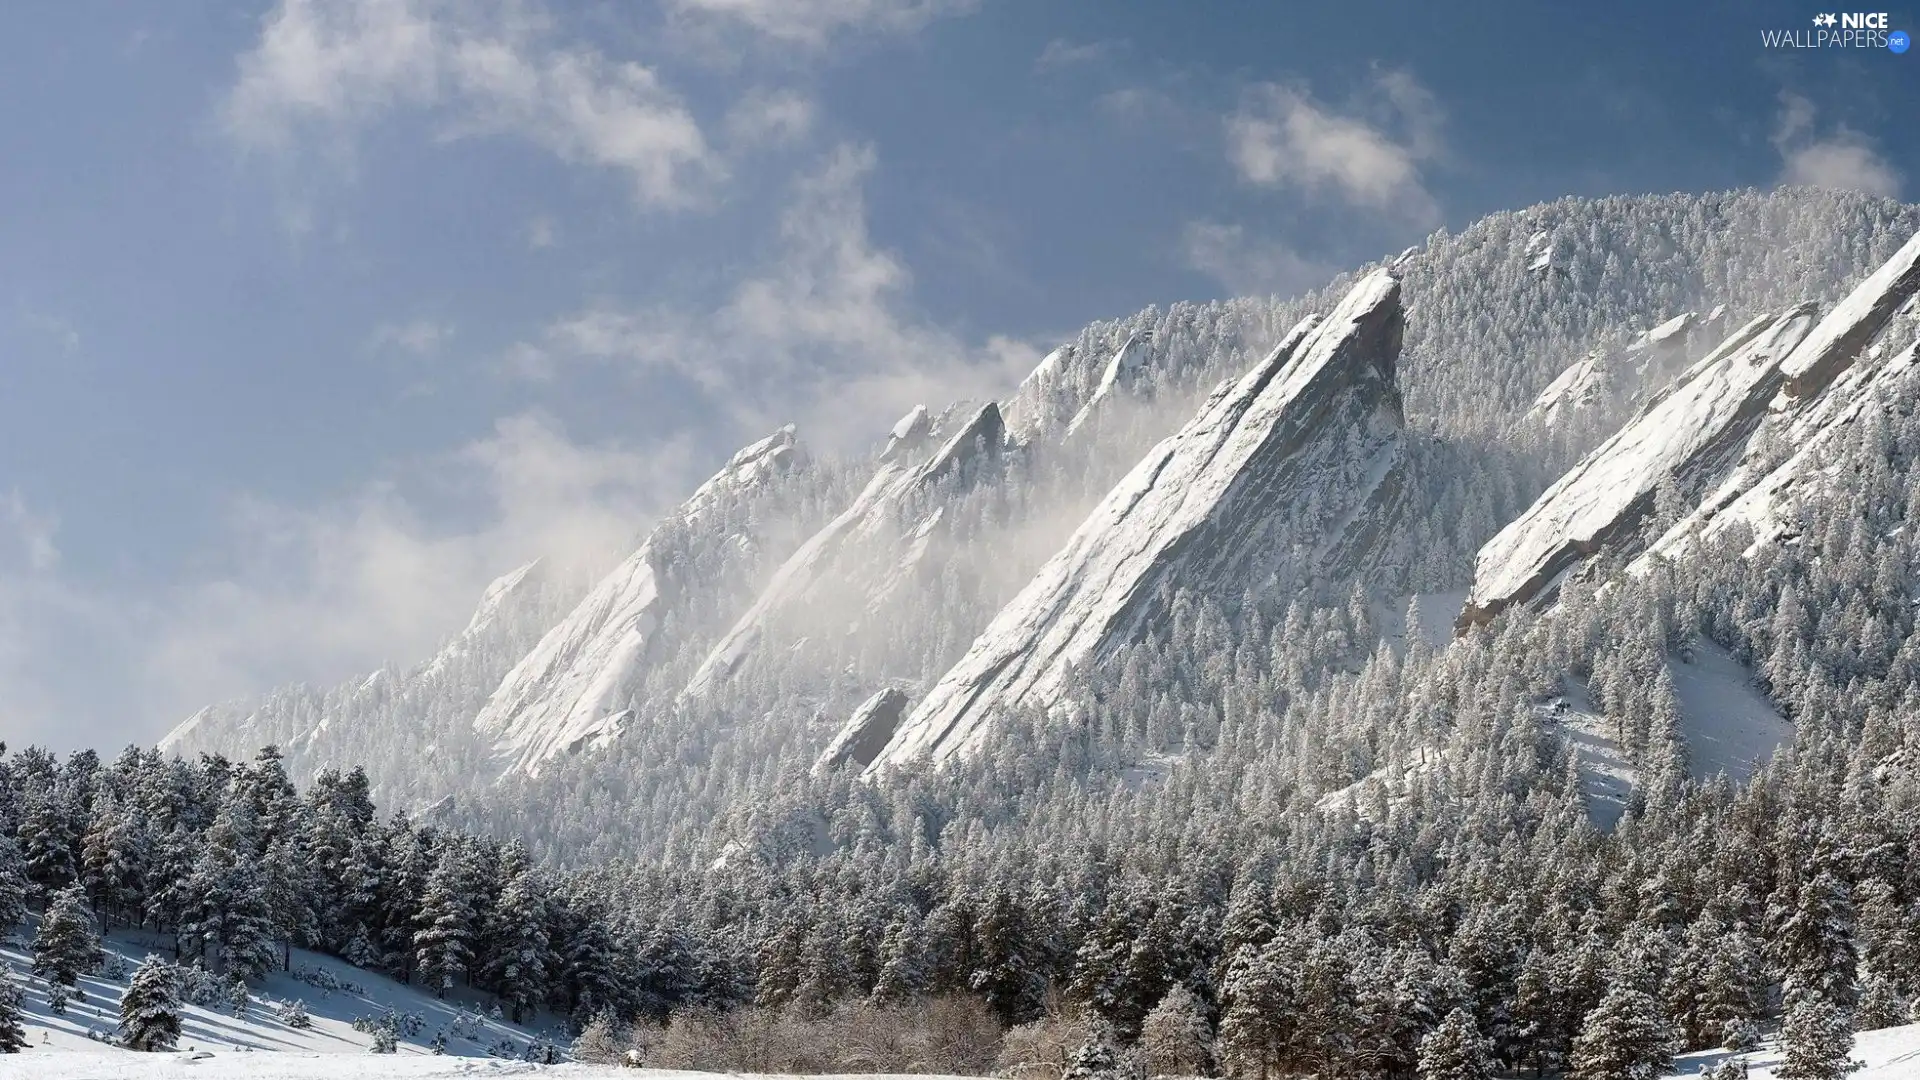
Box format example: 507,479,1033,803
0,914,570,1060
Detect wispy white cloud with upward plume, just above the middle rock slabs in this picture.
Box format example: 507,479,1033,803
507,146,1039,446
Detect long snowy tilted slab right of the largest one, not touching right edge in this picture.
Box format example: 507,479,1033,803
1457,306,1812,628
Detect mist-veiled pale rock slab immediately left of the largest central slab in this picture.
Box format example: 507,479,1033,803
682,402,1006,698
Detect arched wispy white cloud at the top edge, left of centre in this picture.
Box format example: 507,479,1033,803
223,0,722,206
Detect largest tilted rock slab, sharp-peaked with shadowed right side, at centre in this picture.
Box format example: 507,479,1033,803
870,271,1404,771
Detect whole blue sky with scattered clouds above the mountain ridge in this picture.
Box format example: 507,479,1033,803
0,0,1920,748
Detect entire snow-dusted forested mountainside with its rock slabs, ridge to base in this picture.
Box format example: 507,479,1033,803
11,188,1920,1080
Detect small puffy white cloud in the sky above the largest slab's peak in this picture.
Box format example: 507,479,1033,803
1227,71,1442,221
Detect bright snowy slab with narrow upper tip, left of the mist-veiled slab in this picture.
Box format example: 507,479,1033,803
474,427,799,774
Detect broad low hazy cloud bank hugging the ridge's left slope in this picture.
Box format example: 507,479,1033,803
132,415,703,728
